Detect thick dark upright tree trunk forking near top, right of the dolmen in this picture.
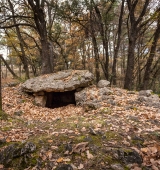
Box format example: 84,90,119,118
124,0,149,90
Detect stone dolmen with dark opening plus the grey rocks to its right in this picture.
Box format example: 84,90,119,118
22,70,160,110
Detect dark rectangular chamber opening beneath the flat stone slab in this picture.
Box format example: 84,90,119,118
46,90,76,108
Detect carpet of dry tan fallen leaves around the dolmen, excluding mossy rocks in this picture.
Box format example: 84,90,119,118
0,84,160,170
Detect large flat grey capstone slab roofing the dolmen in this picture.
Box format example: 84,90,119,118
22,70,94,95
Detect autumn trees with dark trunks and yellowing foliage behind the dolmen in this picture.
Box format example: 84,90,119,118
0,0,160,91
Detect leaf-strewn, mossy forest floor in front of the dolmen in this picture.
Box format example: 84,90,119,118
0,79,160,170
